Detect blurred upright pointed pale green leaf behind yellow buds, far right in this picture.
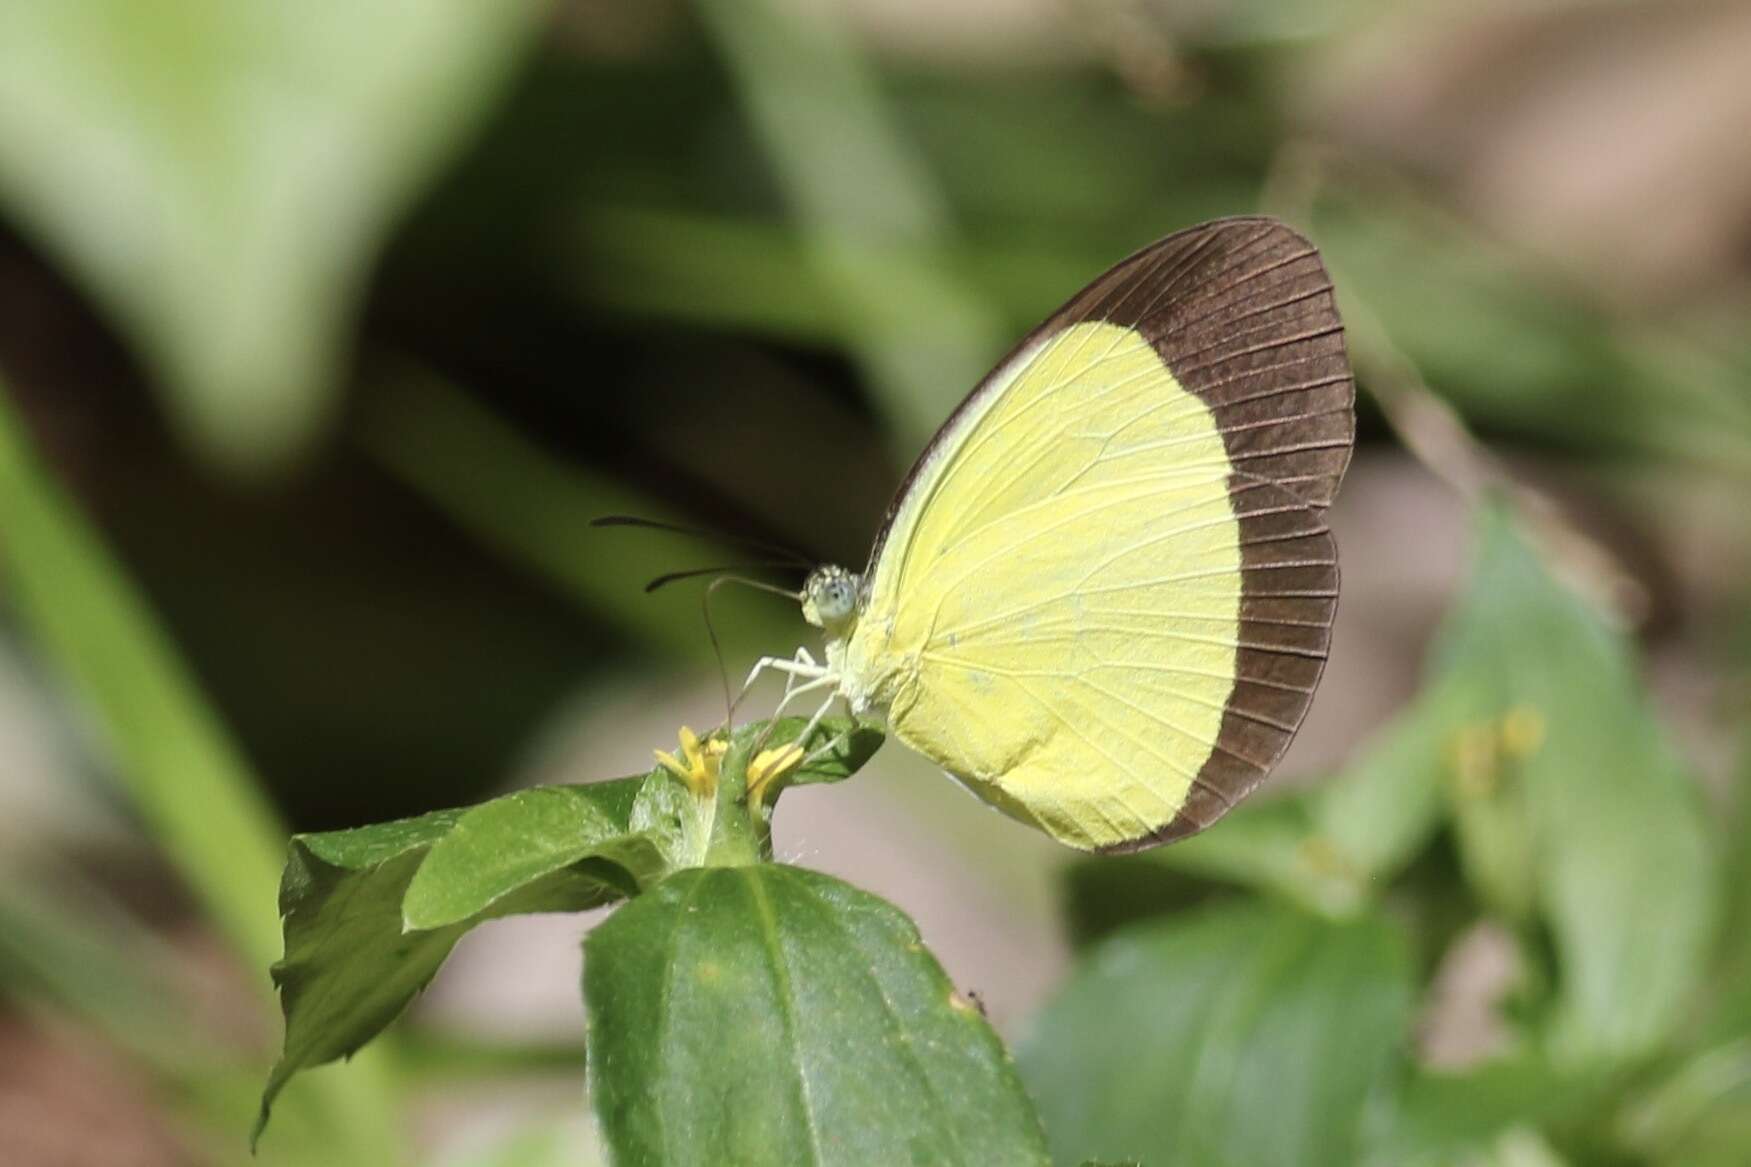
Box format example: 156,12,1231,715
1443,510,1719,1065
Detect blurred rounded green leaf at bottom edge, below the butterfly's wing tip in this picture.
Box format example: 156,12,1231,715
1019,902,1411,1167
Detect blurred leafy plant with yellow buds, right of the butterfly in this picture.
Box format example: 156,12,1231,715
1024,508,1742,1163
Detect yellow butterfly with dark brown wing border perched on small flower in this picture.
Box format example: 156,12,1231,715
749,219,1355,850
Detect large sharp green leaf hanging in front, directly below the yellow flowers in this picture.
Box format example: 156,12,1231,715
583,864,1045,1165
